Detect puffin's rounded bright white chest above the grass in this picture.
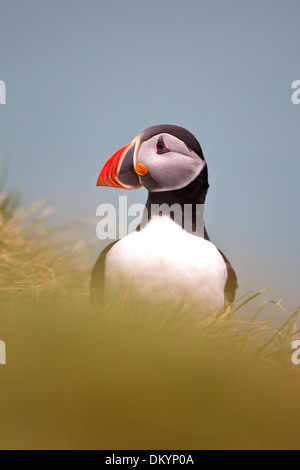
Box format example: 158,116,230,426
105,217,227,316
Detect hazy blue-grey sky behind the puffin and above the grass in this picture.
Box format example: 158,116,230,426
0,0,300,313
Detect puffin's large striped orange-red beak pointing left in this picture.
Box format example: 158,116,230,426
97,142,141,189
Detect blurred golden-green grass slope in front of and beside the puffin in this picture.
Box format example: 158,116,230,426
0,189,300,450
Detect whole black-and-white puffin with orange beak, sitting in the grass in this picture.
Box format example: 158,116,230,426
91,124,238,318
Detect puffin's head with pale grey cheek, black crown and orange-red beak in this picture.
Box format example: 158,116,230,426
97,125,208,192
